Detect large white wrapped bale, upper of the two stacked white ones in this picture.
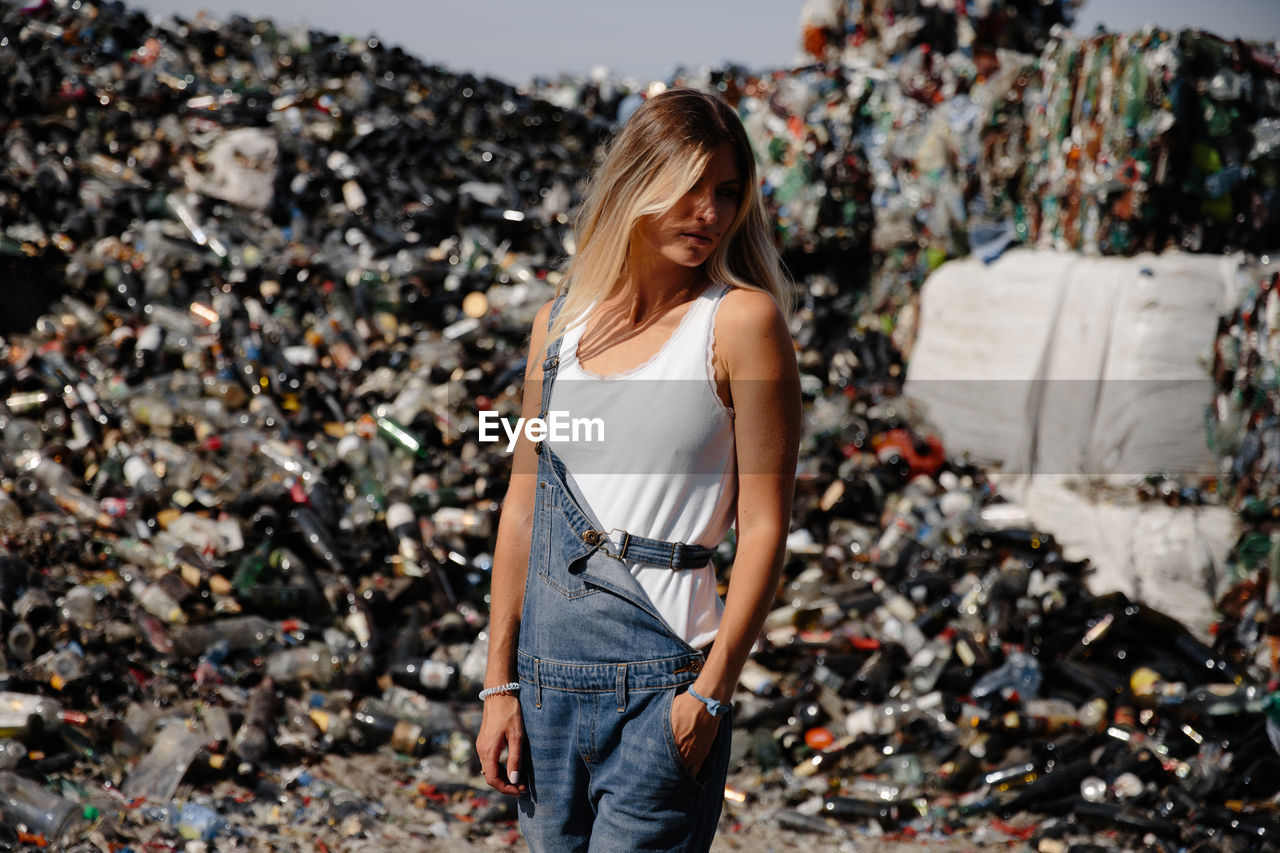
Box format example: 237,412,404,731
905,250,1230,476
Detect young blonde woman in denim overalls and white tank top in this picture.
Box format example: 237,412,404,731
476,90,800,850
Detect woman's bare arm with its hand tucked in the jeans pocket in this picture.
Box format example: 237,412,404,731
672,288,800,770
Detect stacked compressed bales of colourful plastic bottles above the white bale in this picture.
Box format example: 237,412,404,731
650,0,1280,325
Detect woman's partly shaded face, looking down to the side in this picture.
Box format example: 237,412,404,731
634,142,742,268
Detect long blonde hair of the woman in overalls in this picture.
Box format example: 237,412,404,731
536,88,794,360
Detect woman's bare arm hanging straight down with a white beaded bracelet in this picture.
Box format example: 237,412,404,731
476,302,552,794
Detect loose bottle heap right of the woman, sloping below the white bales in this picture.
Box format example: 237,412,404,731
736,389,1280,849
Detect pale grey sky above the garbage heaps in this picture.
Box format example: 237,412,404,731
125,0,1280,83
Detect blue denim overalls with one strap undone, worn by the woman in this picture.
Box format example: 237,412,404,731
517,296,732,853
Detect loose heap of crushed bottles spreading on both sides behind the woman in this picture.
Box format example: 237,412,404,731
0,0,1280,850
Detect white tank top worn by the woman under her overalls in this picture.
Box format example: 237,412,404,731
547,284,737,648
